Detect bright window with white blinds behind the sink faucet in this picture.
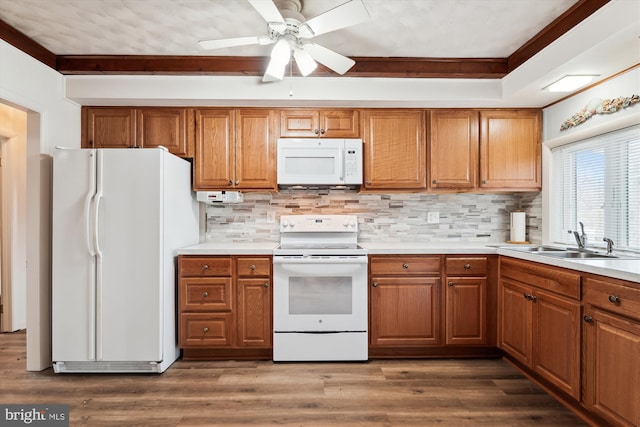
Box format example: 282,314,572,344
550,126,640,252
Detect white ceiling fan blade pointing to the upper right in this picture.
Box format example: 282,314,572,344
300,0,371,38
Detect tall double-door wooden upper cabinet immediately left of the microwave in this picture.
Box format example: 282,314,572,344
193,108,276,191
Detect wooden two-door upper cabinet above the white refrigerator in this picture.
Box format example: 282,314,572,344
82,107,193,157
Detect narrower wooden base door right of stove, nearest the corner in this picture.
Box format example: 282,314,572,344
445,277,487,345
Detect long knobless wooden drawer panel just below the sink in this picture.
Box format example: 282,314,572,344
500,257,581,299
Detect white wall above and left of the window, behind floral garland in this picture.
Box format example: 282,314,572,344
542,66,640,247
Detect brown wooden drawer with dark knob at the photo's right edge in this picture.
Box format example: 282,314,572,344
583,277,640,319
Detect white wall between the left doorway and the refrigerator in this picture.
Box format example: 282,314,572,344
0,40,80,370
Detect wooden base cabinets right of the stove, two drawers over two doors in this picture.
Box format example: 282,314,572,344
369,255,497,357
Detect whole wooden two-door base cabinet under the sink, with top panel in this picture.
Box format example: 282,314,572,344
498,257,581,399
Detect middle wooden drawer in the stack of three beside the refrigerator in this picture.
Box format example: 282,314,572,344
180,277,233,311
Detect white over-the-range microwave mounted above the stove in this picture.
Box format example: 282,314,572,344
278,138,362,186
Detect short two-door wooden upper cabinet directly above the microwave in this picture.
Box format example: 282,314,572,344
280,109,360,138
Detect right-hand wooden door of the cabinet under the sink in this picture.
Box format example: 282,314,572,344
532,290,580,400
